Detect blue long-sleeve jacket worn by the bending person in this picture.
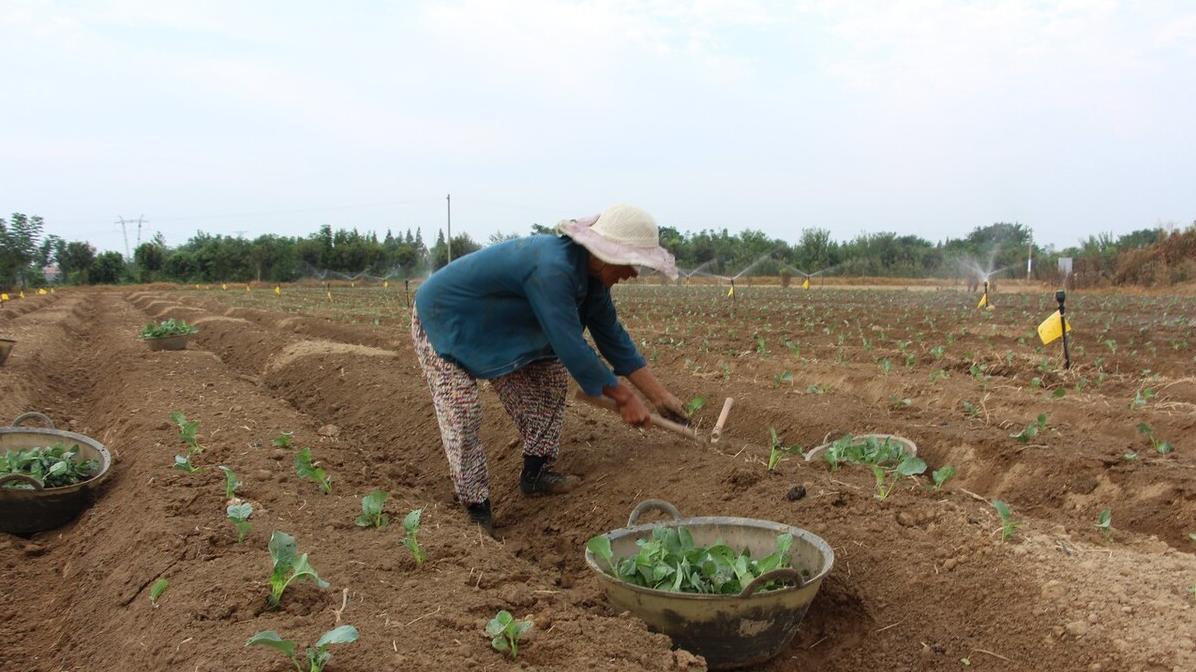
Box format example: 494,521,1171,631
415,236,645,395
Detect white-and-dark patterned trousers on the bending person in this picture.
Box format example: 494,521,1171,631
411,311,569,505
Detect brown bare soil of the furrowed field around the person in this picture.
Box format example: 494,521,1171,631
0,282,1196,672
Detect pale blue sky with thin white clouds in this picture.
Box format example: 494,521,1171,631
0,0,1196,251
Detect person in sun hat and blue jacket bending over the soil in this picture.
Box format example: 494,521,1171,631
411,206,685,531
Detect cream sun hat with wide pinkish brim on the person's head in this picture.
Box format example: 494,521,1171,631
556,204,677,279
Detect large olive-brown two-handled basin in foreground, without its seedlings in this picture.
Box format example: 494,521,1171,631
586,500,835,670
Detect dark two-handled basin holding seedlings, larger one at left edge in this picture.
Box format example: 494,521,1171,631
0,413,112,534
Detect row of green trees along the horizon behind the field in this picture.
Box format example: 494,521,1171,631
0,213,1196,288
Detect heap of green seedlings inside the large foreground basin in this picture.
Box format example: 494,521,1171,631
586,527,793,594
